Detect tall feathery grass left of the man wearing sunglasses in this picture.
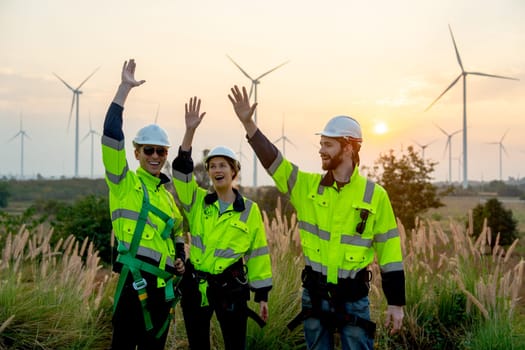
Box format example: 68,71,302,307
0,226,110,349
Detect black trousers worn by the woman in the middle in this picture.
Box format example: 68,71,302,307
181,277,249,350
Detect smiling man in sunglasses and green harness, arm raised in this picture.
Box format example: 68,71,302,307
102,59,185,350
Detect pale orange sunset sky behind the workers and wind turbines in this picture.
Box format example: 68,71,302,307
0,0,525,186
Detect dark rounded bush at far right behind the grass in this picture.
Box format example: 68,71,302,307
472,198,518,247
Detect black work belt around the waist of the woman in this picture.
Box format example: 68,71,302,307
183,259,266,328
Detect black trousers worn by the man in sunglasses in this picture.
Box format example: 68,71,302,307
111,276,173,350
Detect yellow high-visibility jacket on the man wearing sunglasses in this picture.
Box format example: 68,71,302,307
102,104,184,287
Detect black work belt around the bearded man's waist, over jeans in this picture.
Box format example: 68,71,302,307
288,266,376,339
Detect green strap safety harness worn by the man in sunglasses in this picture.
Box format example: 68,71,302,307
113,179,181,339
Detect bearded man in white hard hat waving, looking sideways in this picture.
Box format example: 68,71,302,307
228,86,405,350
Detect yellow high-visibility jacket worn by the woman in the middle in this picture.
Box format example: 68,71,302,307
172,151,272,301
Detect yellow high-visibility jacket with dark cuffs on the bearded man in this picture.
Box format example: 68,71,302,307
249,130,405,305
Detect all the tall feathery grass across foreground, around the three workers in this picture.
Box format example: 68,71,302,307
0,203,525,350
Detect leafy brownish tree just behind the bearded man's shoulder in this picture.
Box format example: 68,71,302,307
364,146,450,229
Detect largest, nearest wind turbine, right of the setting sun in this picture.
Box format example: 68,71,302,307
425,25,519,189
